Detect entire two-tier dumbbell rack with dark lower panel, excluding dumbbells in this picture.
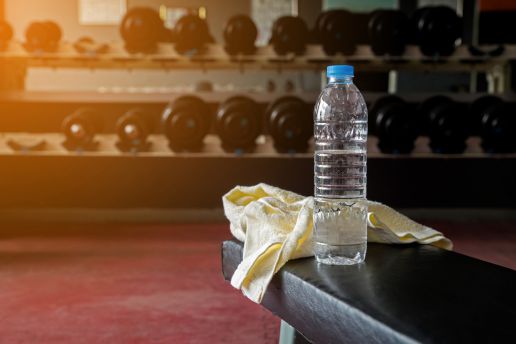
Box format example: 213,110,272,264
0,42,516,209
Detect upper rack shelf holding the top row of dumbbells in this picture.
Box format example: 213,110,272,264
0,42,516,92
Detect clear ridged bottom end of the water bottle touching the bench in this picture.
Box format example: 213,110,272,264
314,242,367,265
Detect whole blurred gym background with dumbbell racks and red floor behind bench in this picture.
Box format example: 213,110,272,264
0,0,516,343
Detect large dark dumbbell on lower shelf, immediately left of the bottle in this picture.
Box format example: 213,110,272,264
267,96,313,153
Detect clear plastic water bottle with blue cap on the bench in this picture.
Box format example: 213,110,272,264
314,65,367,265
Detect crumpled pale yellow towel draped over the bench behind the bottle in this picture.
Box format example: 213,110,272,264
222,184,452,303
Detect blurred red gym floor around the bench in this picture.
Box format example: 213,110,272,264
0,223,516,344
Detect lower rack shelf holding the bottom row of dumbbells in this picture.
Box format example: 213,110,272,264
0,133,516,161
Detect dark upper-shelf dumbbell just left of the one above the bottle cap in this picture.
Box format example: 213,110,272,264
270,16,309,55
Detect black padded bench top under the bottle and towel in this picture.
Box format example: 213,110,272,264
222,241,516,343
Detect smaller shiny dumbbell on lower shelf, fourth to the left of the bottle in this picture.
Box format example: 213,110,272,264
115,109,151,152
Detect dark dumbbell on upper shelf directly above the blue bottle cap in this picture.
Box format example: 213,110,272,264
314,10,357,55
